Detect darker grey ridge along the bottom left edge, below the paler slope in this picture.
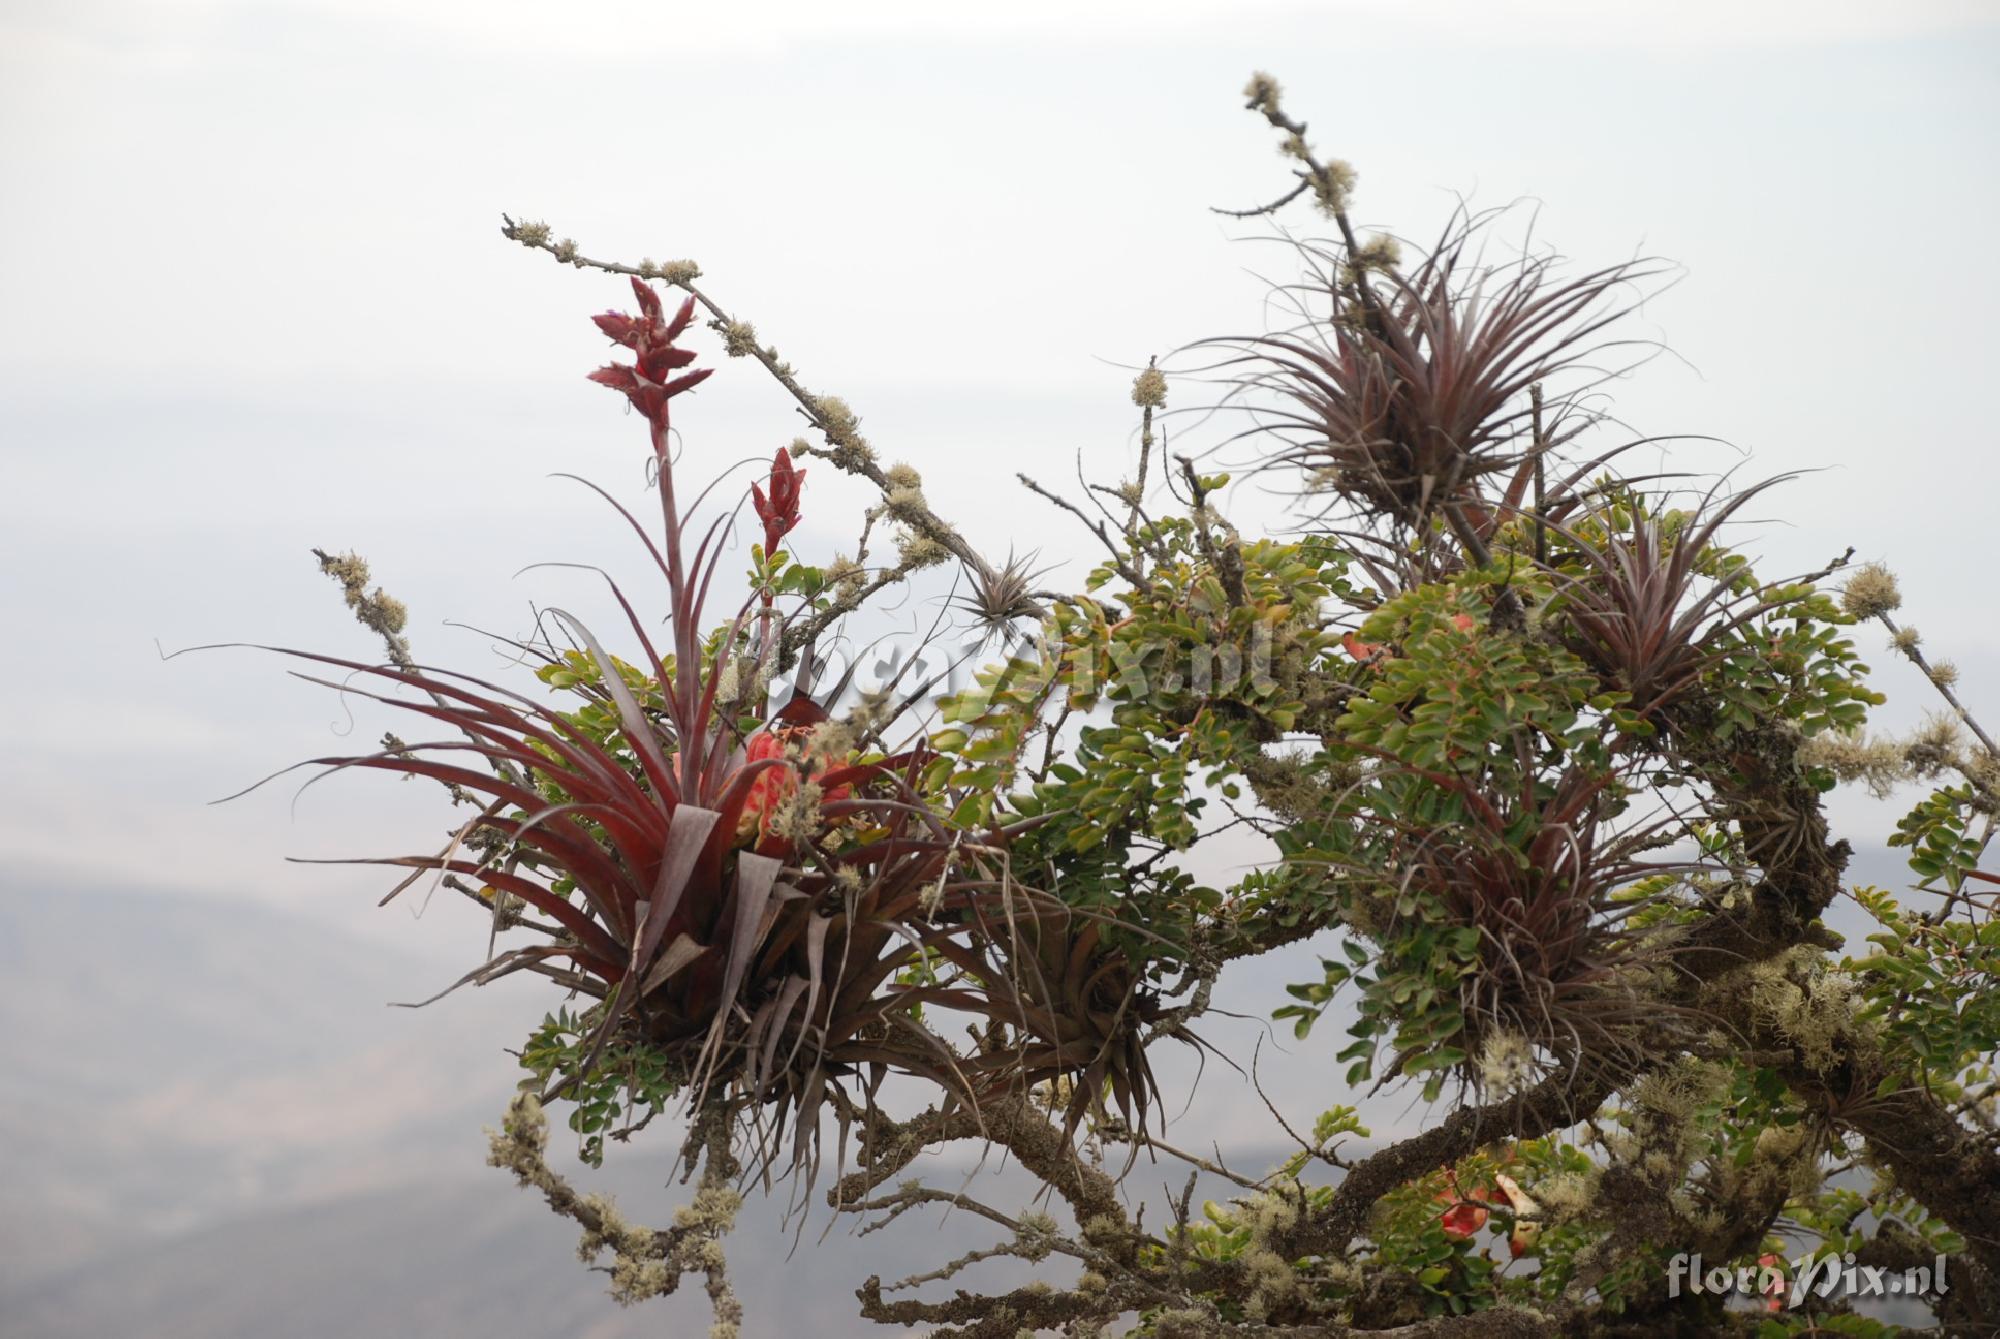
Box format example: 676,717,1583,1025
4,1175,936,1339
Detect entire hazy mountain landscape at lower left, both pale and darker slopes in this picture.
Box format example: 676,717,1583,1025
0,887,1080,1339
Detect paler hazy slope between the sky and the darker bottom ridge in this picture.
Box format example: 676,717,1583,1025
0,887,538,1285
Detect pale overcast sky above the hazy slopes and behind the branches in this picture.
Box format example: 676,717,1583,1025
0,0,2000,967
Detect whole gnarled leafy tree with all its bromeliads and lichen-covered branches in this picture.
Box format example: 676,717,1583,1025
246,76,2000,1339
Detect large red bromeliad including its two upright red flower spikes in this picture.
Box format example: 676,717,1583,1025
268,278,1128,1199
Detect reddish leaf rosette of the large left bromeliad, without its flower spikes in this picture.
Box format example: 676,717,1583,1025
260,652,1004,1167
